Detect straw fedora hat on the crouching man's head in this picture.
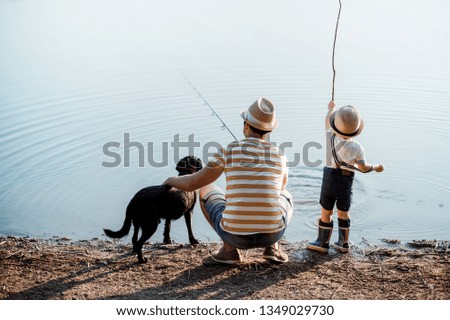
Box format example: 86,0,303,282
241,97,278,131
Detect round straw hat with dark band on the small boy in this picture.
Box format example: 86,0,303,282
329,105,364,138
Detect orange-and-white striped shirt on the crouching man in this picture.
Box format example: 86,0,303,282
211,138,287,235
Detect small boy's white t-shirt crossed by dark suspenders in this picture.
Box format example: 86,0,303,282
325,129,366,171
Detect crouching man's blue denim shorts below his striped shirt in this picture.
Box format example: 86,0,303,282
202,191,293,249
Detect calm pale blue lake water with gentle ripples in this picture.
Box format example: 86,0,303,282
0,0,450,243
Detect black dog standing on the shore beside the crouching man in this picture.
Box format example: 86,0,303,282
103,156,202,263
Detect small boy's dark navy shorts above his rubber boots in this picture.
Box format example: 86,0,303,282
320,167,355,211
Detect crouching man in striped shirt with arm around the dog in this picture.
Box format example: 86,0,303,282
164,98,293,264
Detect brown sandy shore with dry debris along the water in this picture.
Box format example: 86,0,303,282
0,237,450,300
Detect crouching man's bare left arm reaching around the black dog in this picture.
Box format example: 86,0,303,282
164,163,223,191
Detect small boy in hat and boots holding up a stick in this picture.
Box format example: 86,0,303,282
307,101,384,253
